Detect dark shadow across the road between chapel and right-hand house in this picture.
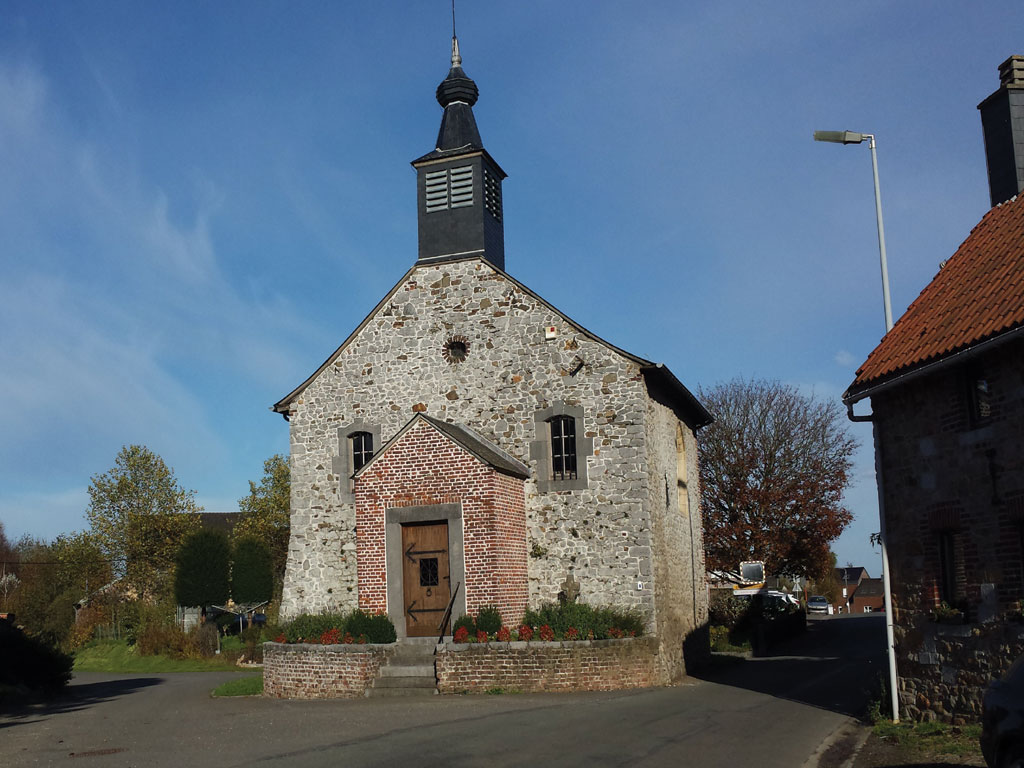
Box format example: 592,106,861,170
691,614,886,717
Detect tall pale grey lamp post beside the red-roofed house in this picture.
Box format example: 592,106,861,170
814,131,899,723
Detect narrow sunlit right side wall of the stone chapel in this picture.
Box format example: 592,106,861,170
644,391,709,678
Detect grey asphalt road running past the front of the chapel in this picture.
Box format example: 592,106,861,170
0,616,885,768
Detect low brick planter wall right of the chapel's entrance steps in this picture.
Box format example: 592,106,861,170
436,637,668,693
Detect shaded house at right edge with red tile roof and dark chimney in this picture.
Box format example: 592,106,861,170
844,56,1024,720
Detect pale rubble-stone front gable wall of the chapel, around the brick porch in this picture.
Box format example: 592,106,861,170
282,260,653,617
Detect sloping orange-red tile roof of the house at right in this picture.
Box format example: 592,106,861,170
844,195,1024,399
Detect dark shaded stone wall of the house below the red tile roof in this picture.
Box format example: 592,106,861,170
871,335,1024,719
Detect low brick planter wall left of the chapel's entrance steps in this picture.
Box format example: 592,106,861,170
263,643,394,698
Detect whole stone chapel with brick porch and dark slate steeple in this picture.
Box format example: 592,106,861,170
272,38,711,676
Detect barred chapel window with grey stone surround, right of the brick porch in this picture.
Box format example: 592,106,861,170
529,400,594,494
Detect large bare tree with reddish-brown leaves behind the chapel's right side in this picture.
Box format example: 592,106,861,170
699,379,857,579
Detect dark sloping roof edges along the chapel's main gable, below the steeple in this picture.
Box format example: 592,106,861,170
270,256,715,429
